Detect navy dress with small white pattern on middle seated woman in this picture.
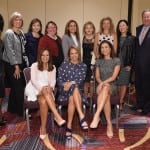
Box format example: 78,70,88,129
57,61,87,101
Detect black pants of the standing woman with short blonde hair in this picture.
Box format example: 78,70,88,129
5,63,25,116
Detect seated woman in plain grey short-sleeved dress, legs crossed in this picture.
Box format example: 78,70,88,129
90,40,120,138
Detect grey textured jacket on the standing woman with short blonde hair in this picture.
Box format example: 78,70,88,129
3,29,22,65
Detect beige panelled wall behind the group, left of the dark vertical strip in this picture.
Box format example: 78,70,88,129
0,0,128,36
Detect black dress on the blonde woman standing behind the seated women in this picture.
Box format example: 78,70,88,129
82,38,94,82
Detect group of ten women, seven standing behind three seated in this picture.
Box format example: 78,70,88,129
0,12,135,149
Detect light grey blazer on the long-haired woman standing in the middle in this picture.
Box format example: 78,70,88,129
62,34,81,59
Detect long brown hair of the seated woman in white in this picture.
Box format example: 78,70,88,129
37,48,54,71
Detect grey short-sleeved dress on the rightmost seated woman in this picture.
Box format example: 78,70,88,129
96,57,121,95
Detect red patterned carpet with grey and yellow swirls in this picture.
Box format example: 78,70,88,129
0,106,150,150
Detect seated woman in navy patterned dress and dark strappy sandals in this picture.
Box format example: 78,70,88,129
58,46,88,139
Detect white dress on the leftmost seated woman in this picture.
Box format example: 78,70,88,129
25,62,56,101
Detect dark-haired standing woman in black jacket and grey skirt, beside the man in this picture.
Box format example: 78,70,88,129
116,20,135,110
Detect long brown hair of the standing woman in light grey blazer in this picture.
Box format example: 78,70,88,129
64,20,80,41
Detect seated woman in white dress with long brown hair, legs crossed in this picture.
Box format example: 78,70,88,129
25,49,65,149
